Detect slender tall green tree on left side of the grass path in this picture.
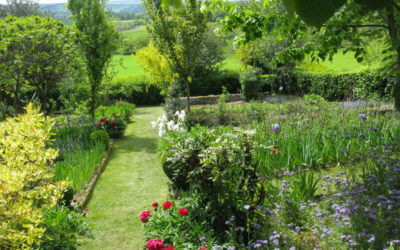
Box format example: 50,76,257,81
68,0,119,118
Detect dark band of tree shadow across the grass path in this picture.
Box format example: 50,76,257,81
116,135,158,154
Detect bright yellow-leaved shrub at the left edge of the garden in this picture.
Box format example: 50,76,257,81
0,105,66,249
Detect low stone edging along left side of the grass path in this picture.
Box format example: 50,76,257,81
74,142,114,207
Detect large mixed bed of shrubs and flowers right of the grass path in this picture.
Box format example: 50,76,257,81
148,101,400,249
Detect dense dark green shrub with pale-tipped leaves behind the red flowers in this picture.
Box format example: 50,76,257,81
160,127,265,241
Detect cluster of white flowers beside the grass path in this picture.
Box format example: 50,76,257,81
151,110,186,136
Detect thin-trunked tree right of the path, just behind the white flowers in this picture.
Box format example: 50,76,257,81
143,0,208,112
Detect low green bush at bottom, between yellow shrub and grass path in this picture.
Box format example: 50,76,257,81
38,206,93,250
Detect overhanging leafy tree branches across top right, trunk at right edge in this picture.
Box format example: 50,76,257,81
208,0,400,110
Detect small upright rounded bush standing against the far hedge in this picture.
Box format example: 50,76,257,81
240,68,261,101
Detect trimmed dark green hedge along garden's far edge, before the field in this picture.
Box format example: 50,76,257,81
108,71,394,105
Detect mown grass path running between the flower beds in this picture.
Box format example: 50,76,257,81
81,107,168,250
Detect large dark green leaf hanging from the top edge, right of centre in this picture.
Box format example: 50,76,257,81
287,0,346,27
